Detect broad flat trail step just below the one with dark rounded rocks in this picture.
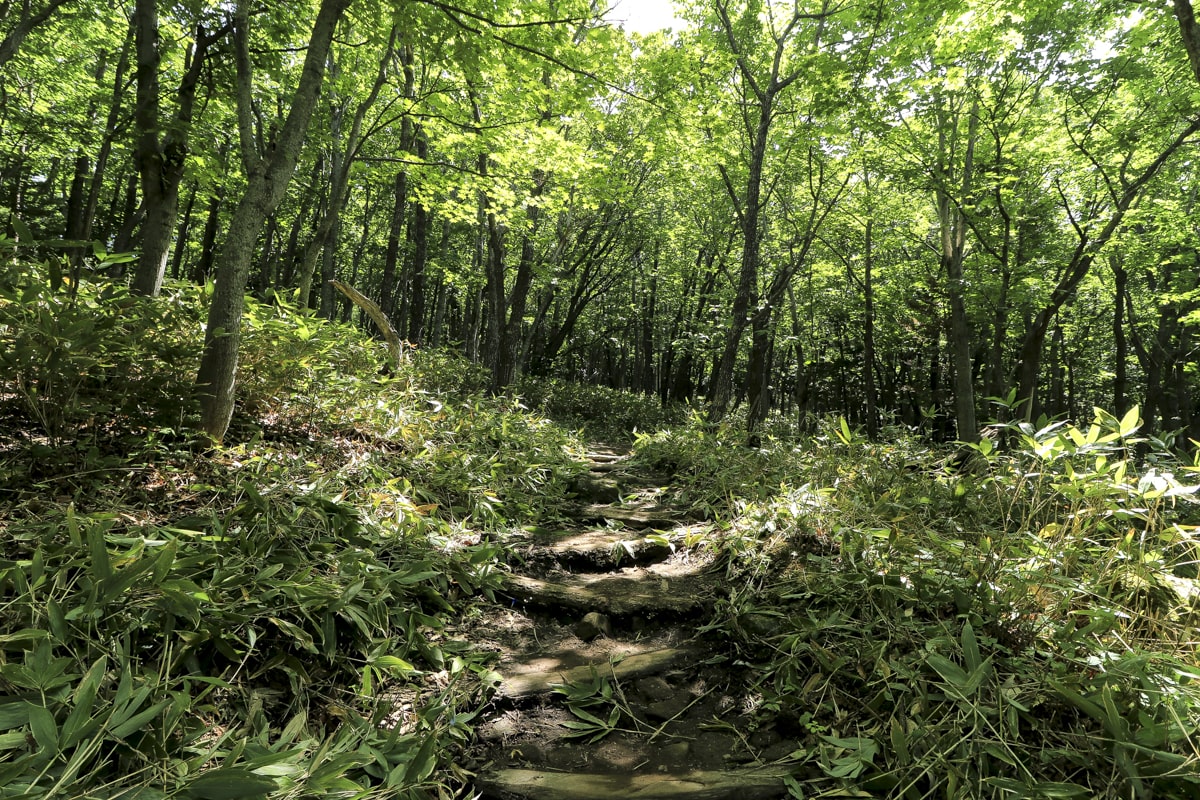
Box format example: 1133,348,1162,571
504,571,712,615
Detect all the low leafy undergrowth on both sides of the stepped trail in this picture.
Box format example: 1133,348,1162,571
0,271,1200,800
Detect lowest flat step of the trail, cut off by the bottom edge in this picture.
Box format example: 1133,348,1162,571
476,766,788,800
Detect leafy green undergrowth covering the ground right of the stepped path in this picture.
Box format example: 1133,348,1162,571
657,409,1200,799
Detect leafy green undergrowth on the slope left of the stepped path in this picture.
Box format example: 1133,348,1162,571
0,273,582,800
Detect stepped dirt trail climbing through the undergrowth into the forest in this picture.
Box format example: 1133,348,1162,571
470,447,796,800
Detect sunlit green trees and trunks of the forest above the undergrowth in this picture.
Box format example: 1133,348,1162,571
0,0,1200,441
